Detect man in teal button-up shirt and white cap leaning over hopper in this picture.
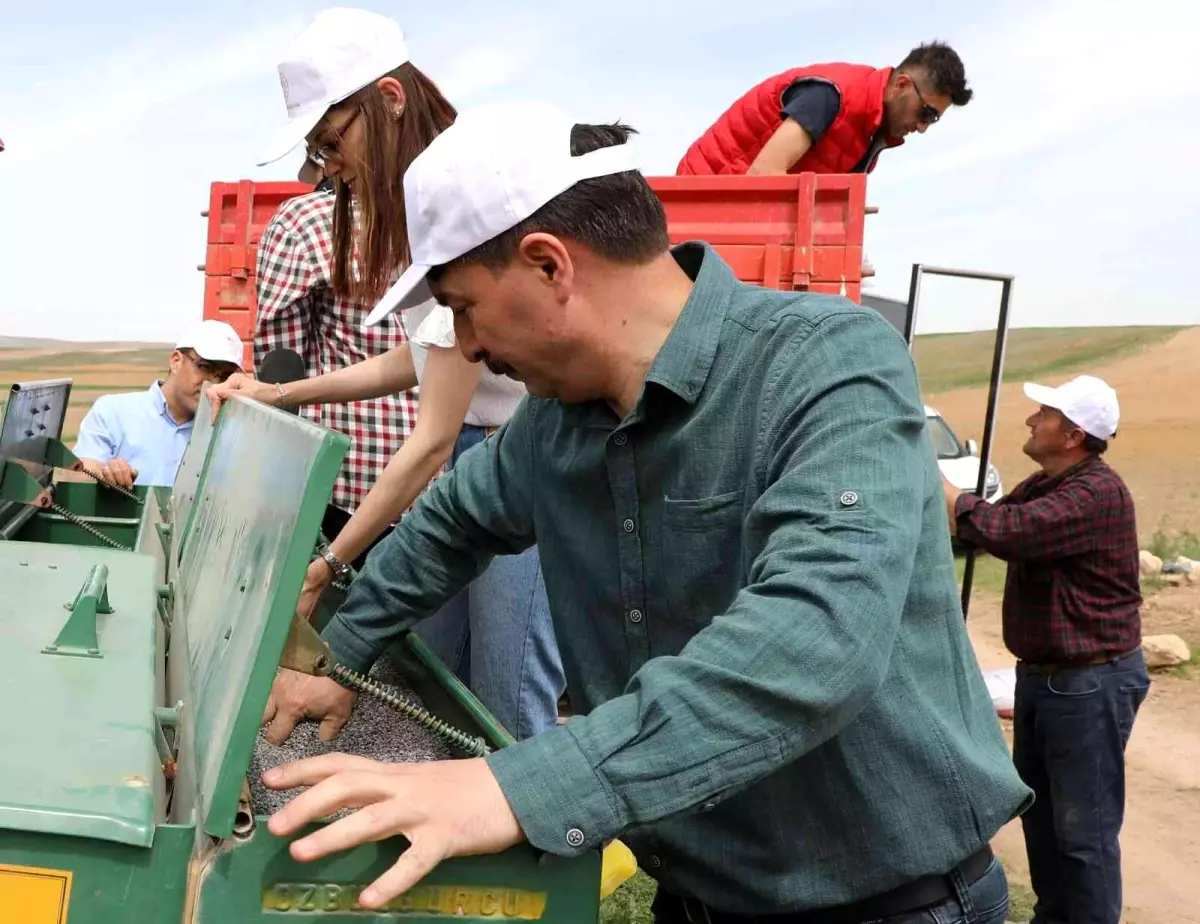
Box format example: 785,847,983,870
264,104,1030,924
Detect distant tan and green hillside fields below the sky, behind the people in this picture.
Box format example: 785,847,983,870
7,328,1200,541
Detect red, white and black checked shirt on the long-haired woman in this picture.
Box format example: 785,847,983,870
254,192,418,514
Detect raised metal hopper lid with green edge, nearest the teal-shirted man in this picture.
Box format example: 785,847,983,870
172,398,349,838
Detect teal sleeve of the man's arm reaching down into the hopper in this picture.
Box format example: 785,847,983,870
322,402,534,672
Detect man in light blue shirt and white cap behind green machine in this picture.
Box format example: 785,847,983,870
73,320,242,488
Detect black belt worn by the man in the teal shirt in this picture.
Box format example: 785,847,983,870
654,845,992,924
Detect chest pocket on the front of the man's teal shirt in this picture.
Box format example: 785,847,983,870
659,491,743,625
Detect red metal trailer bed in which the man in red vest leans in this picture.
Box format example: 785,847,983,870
199,173,868,368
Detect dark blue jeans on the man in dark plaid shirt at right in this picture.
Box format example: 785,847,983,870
1013,649,1150,924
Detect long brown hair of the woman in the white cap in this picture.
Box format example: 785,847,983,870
331,64,457,302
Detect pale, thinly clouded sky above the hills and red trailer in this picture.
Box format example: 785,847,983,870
0,0,1200,340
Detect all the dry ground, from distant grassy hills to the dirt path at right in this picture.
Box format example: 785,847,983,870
0,328,1200,924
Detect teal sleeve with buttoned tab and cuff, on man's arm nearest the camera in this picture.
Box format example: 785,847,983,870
487,312,926,854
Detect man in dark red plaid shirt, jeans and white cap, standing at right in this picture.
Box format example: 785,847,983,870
943,376,1150,924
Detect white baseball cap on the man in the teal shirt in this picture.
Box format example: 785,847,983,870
364,102,637,328
